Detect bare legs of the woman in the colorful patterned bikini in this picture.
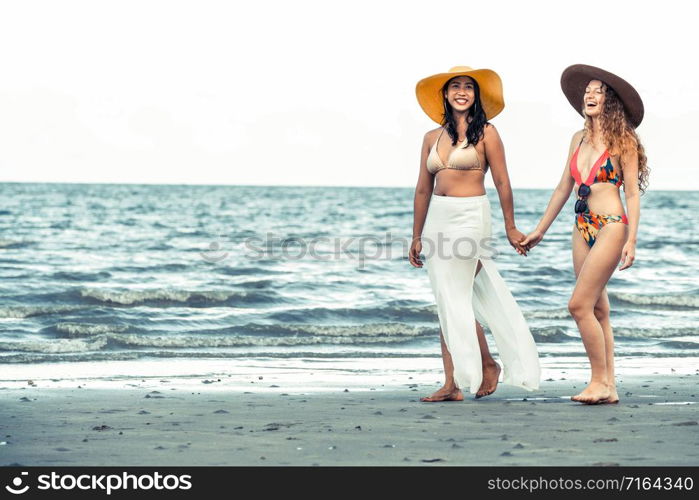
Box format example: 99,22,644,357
568,223,627,404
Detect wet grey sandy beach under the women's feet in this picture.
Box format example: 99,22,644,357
0,358,699,466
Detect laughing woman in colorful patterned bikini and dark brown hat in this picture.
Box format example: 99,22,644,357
521,64,649,404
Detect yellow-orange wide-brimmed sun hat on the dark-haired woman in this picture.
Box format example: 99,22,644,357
415,66,505,125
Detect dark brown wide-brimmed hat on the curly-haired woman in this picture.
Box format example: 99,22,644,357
561,64,643,128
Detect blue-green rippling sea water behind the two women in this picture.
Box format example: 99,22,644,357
0,183,699,364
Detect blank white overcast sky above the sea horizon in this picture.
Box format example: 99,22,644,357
0,0,699,189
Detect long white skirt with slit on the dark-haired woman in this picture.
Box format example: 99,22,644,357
422,194,541,393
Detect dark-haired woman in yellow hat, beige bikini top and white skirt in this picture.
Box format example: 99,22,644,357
409,66,540,403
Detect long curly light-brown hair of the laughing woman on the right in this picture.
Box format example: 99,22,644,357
583,82,650,194
